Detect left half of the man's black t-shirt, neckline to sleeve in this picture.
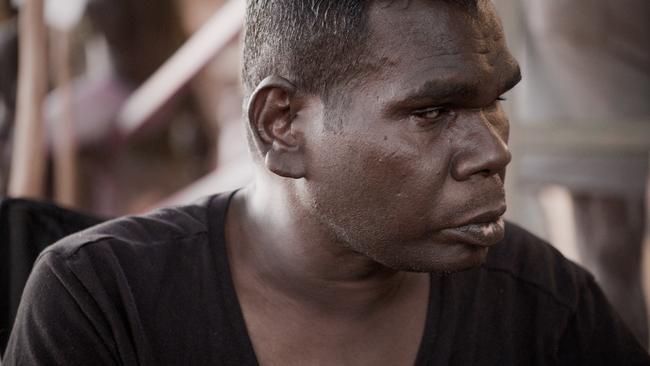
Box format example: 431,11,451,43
5,195,240,364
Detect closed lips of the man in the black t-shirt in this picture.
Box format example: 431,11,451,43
440,207,505,247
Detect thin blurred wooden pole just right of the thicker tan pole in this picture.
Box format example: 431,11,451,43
50,29,77,207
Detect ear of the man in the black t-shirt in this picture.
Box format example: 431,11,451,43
248,76,306,179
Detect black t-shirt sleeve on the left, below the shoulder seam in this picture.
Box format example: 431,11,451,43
4,252,118,366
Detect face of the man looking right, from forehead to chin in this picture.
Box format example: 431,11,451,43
299,0,519,271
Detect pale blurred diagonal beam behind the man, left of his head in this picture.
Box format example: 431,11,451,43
117,0,245,136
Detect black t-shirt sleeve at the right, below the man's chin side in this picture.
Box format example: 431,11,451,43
559,276,650,366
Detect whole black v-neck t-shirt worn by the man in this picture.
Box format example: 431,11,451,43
5,195,650,366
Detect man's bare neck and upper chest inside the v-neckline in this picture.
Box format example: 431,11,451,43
226,184,429,365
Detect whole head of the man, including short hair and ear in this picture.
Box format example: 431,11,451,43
244,0,519,271
